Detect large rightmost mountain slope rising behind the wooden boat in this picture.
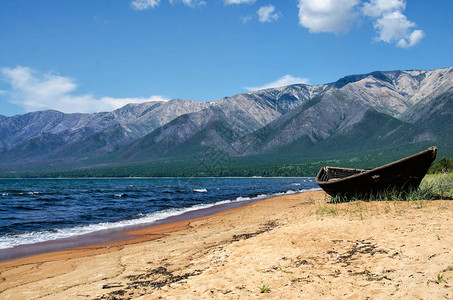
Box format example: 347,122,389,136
230,68,453,155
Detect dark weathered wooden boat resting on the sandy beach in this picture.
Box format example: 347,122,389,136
316,146,437,197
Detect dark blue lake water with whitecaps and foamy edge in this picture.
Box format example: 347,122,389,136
0,178,318,249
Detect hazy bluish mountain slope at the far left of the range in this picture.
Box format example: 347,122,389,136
0,100,209,163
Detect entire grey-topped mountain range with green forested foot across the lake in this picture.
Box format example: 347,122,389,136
0,67,453,176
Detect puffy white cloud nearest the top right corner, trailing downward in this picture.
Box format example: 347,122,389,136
362,0,425,48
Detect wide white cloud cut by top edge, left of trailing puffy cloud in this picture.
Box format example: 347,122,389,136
298,0,359,33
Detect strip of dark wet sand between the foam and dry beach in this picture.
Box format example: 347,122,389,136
0,189,317,263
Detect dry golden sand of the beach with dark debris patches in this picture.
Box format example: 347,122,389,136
0,191,453,299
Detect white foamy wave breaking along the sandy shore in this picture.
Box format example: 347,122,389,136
0,188,320,249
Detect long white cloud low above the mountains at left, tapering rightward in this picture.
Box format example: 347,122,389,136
0,66,167,113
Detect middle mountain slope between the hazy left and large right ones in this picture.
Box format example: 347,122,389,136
107,85,324,160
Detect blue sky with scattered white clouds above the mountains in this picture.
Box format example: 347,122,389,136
0,0,453,116
